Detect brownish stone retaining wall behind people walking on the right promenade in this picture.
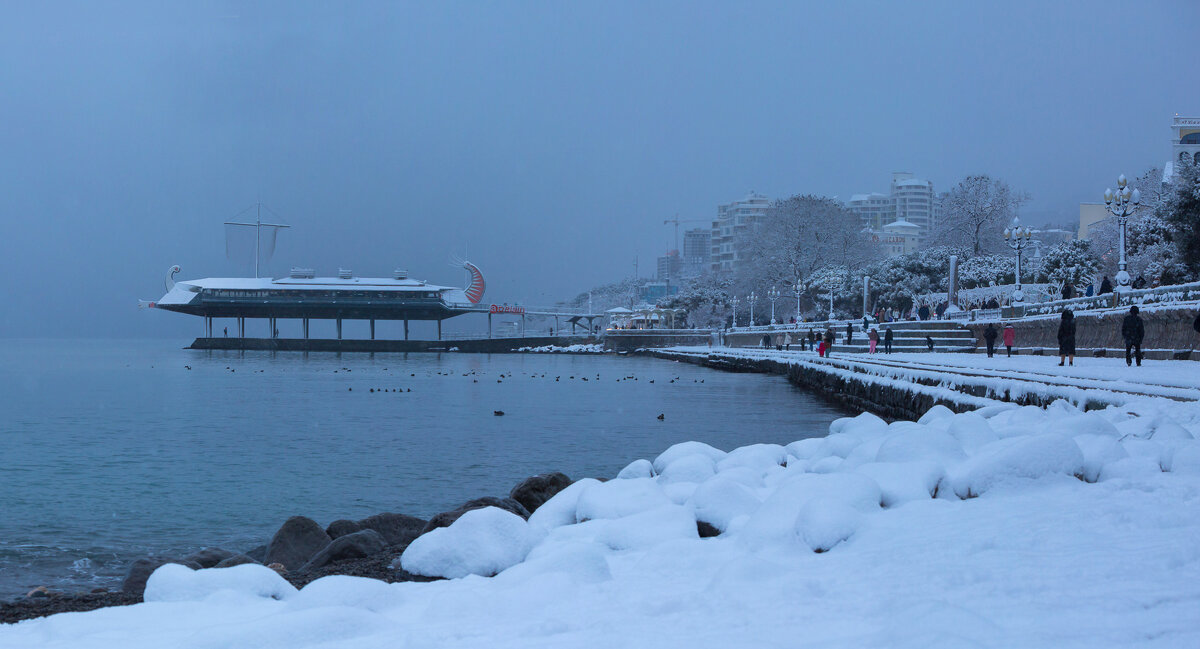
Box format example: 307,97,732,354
964,307,1200,360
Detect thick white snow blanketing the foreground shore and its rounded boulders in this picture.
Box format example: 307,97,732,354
0,367,1200,649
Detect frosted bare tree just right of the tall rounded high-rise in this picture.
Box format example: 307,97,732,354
932,174,1028,254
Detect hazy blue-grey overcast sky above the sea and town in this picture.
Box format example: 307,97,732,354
0,0,1200,338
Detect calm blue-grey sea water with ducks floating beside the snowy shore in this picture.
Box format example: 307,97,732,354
0,341,841,599
